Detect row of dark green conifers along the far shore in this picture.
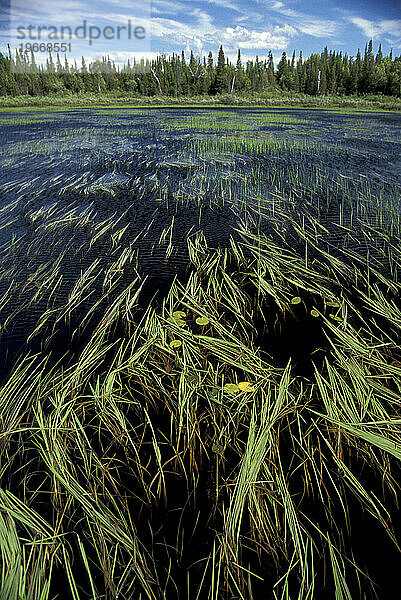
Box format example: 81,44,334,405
0,41,401,97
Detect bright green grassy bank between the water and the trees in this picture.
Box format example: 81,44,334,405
0,94,401,113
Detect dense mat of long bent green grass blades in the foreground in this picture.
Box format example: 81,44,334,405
0,229,401,598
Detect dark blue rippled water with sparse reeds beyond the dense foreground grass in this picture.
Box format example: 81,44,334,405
0,108,401,372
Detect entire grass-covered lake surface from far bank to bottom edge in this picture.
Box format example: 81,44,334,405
0,109,401,600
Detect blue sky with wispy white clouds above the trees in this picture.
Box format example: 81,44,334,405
0,0,401,64
